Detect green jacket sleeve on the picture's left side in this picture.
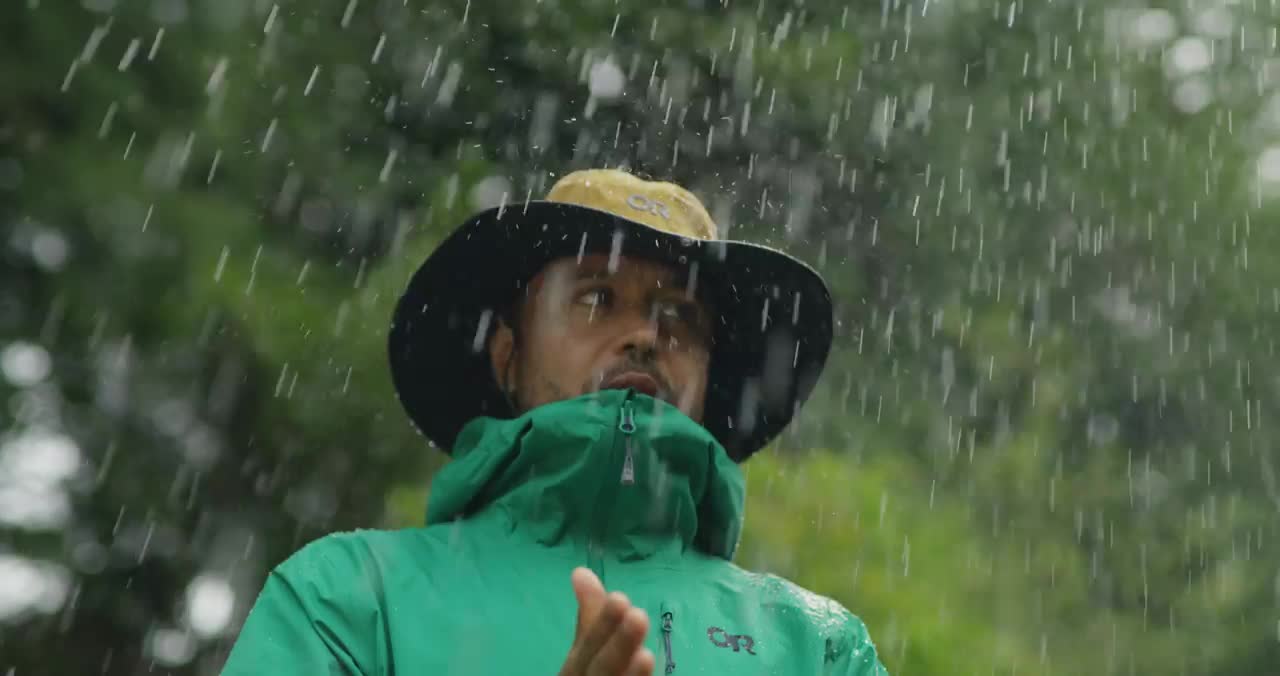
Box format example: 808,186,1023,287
223,536,380,676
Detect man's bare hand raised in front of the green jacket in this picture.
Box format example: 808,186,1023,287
559,568,654,676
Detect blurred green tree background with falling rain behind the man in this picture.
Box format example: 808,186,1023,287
0,0,1280,676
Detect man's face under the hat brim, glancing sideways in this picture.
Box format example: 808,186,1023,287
489,255,712,423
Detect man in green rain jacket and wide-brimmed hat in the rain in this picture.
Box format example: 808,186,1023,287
227,170,884,676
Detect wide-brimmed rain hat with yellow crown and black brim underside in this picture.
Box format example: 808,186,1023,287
388,169,832,462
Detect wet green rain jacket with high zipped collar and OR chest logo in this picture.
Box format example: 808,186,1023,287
224,390,886,676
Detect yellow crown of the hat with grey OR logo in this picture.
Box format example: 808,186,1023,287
547,169,716,239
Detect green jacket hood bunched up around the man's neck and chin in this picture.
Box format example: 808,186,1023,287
426,390,746,563
